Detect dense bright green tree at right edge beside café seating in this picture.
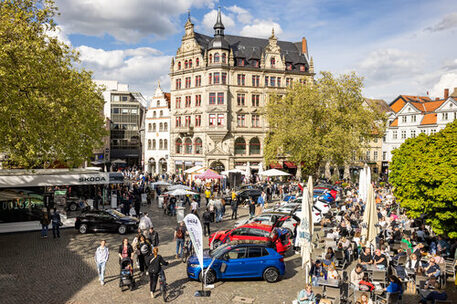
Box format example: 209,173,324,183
389,120,457,238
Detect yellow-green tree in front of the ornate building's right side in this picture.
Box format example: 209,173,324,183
265,72,385,176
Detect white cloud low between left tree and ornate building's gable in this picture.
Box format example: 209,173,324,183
77,46,171,96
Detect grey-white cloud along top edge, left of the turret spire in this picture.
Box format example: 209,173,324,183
57,0,214,43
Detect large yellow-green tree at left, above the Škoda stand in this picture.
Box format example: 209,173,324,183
0,0,106,168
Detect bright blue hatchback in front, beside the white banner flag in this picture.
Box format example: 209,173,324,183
187,241,285,284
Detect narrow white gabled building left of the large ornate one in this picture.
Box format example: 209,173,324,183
143,84,170,174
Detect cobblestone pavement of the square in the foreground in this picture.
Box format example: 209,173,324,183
0,201,457,304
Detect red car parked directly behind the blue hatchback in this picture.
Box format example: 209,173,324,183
209,223,292,254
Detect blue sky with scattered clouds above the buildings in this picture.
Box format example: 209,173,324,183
52,0,457,102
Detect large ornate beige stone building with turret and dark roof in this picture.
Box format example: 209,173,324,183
170,10,314,173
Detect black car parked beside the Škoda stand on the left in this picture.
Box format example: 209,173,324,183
75,209,139,234
